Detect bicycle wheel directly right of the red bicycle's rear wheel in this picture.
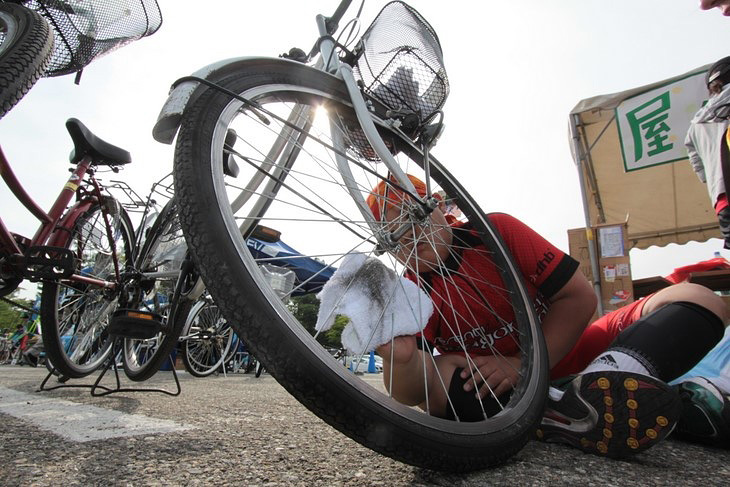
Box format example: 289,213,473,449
123,199,193,381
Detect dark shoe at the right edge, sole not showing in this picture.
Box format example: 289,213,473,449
674,377,730,448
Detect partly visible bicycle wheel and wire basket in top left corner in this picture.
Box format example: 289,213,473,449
0,0,162,118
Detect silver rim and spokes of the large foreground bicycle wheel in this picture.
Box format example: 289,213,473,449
181,84,537,434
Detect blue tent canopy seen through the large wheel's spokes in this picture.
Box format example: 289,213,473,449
246,237,336,296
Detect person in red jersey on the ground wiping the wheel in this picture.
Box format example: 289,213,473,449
316,176,728,458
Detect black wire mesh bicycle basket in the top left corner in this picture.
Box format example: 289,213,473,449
23,0,162,77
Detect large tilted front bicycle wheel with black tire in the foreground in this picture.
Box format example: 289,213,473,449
175,61,548,471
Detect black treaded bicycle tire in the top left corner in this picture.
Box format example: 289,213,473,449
0,3,53,118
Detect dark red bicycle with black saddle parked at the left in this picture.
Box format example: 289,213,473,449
0,118,134,378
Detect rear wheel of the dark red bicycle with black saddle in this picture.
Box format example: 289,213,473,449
41,200,134,379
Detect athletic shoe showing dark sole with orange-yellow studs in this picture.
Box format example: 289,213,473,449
537,371,682,458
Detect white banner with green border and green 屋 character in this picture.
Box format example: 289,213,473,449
616,72,708,171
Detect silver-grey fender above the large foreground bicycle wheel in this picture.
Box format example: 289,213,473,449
152,57,321,144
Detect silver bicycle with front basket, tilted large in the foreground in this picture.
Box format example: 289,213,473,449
154,0,548,470
